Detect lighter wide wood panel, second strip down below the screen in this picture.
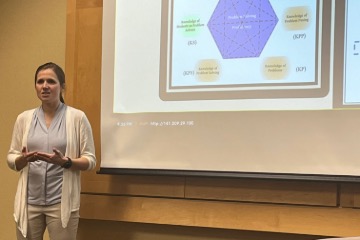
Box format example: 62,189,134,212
80,194,360,236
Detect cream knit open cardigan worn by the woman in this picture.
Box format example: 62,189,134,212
7,106,96,237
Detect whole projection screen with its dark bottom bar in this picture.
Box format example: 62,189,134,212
99,0,360,181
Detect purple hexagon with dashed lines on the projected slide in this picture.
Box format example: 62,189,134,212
207,0,279,59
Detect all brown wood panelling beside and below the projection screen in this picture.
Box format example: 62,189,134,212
66,0,360,240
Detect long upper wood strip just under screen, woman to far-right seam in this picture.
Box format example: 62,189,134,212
83,174,338,207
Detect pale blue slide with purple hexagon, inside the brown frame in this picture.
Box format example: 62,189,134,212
162,0,320,94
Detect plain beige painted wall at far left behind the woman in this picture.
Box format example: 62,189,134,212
0,0,66,240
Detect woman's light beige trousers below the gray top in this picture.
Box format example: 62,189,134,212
16,203,79,240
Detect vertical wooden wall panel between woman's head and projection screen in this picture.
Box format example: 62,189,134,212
72,7,102,186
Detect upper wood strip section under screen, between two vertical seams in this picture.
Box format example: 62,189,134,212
185,178,337,206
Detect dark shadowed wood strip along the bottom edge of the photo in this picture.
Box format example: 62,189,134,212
78,219,323,240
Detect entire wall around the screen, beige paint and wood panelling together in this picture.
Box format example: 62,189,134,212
0,0,360,240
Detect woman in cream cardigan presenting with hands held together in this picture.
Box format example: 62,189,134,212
7,62,96,240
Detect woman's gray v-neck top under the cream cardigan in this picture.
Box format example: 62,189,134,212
27,103,66,206
